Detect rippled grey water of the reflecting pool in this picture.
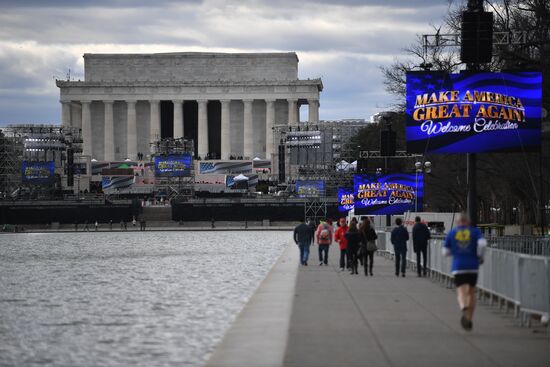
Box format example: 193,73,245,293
0,231,290,366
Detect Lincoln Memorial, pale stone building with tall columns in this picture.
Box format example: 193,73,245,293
56,52,323,161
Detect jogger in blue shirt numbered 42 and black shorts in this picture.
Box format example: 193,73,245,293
442,213,487,331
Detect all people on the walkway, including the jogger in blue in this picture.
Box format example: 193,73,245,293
294,213,487,331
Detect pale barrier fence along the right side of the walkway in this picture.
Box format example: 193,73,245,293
378,232,550,325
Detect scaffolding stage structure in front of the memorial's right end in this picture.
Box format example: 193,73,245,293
273,119,367,220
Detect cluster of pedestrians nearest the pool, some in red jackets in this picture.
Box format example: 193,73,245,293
294,218,378,276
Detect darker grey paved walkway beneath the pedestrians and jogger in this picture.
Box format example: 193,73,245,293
284,246,550,367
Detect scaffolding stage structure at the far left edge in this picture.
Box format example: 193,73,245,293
0,124,82,196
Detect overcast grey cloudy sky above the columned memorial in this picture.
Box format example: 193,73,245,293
0,0,449,125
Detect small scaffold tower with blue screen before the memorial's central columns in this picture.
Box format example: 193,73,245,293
151,138,195,201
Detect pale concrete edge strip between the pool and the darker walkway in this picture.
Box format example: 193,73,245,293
205,244,299,367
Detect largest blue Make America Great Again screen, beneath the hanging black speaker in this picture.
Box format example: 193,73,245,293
406,72,542,154
